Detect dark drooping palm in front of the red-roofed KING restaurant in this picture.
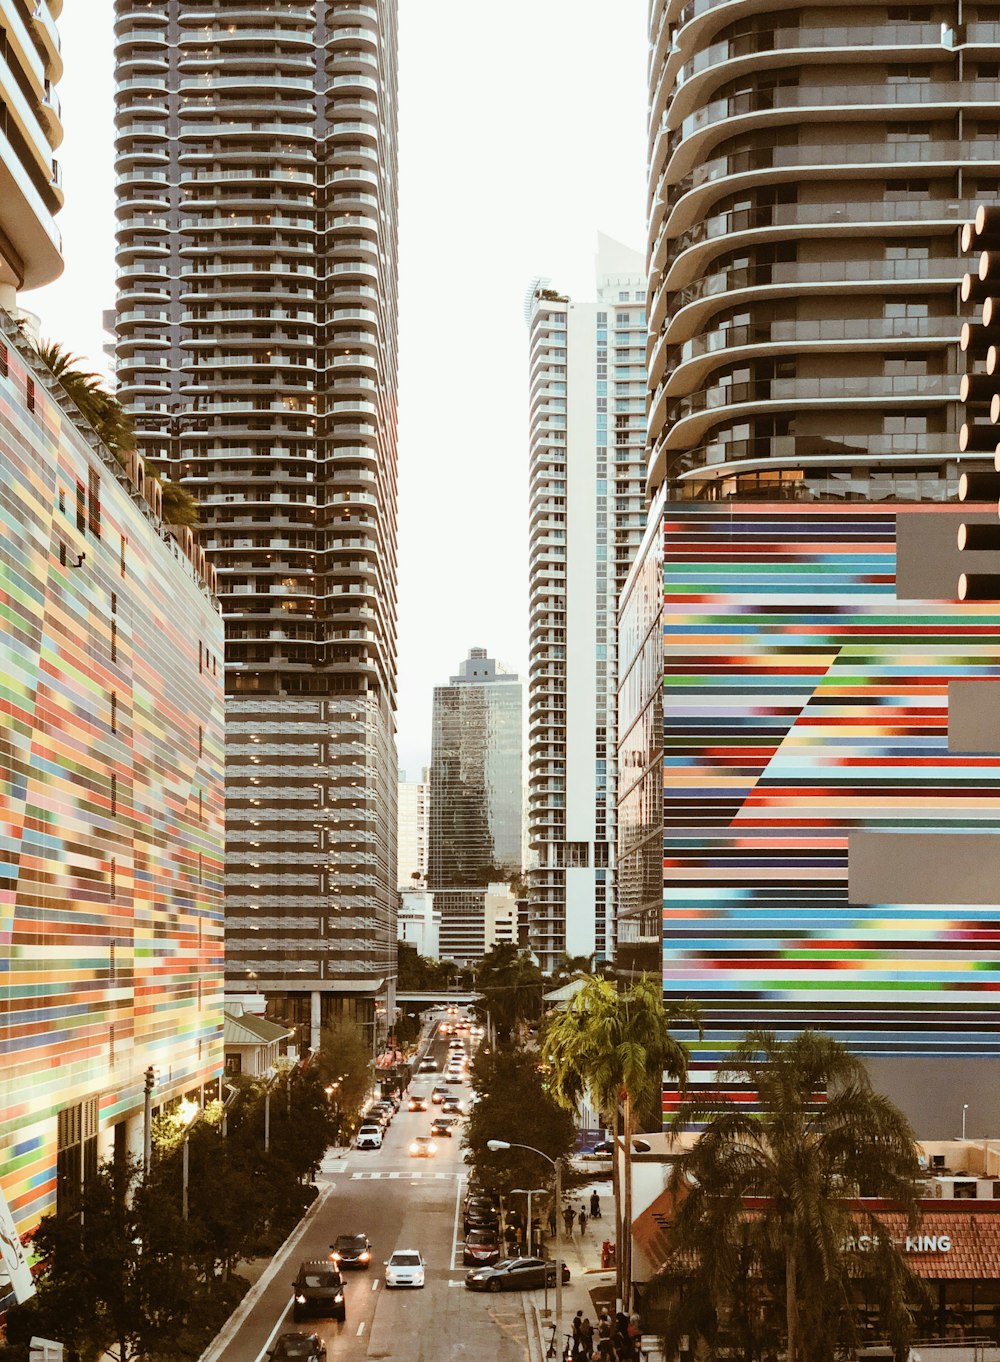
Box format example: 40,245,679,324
663,1031,918,1362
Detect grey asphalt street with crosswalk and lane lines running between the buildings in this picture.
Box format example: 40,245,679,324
218,1018,526,1362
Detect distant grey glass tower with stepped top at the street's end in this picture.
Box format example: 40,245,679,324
428,648,523,914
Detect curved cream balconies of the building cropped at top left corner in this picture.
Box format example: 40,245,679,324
0,0,63,312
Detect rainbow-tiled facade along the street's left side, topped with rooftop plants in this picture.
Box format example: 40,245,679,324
0,324,223,1233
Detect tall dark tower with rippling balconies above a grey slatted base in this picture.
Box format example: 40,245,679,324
116,0,396,1045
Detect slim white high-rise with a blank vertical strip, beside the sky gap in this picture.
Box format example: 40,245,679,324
527,236,646,970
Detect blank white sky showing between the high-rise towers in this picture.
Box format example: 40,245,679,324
31,0,646,779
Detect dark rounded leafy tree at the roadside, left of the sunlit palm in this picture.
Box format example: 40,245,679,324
465,1049,576,1196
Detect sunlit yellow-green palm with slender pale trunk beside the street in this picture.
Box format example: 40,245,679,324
542,975,698,1309
